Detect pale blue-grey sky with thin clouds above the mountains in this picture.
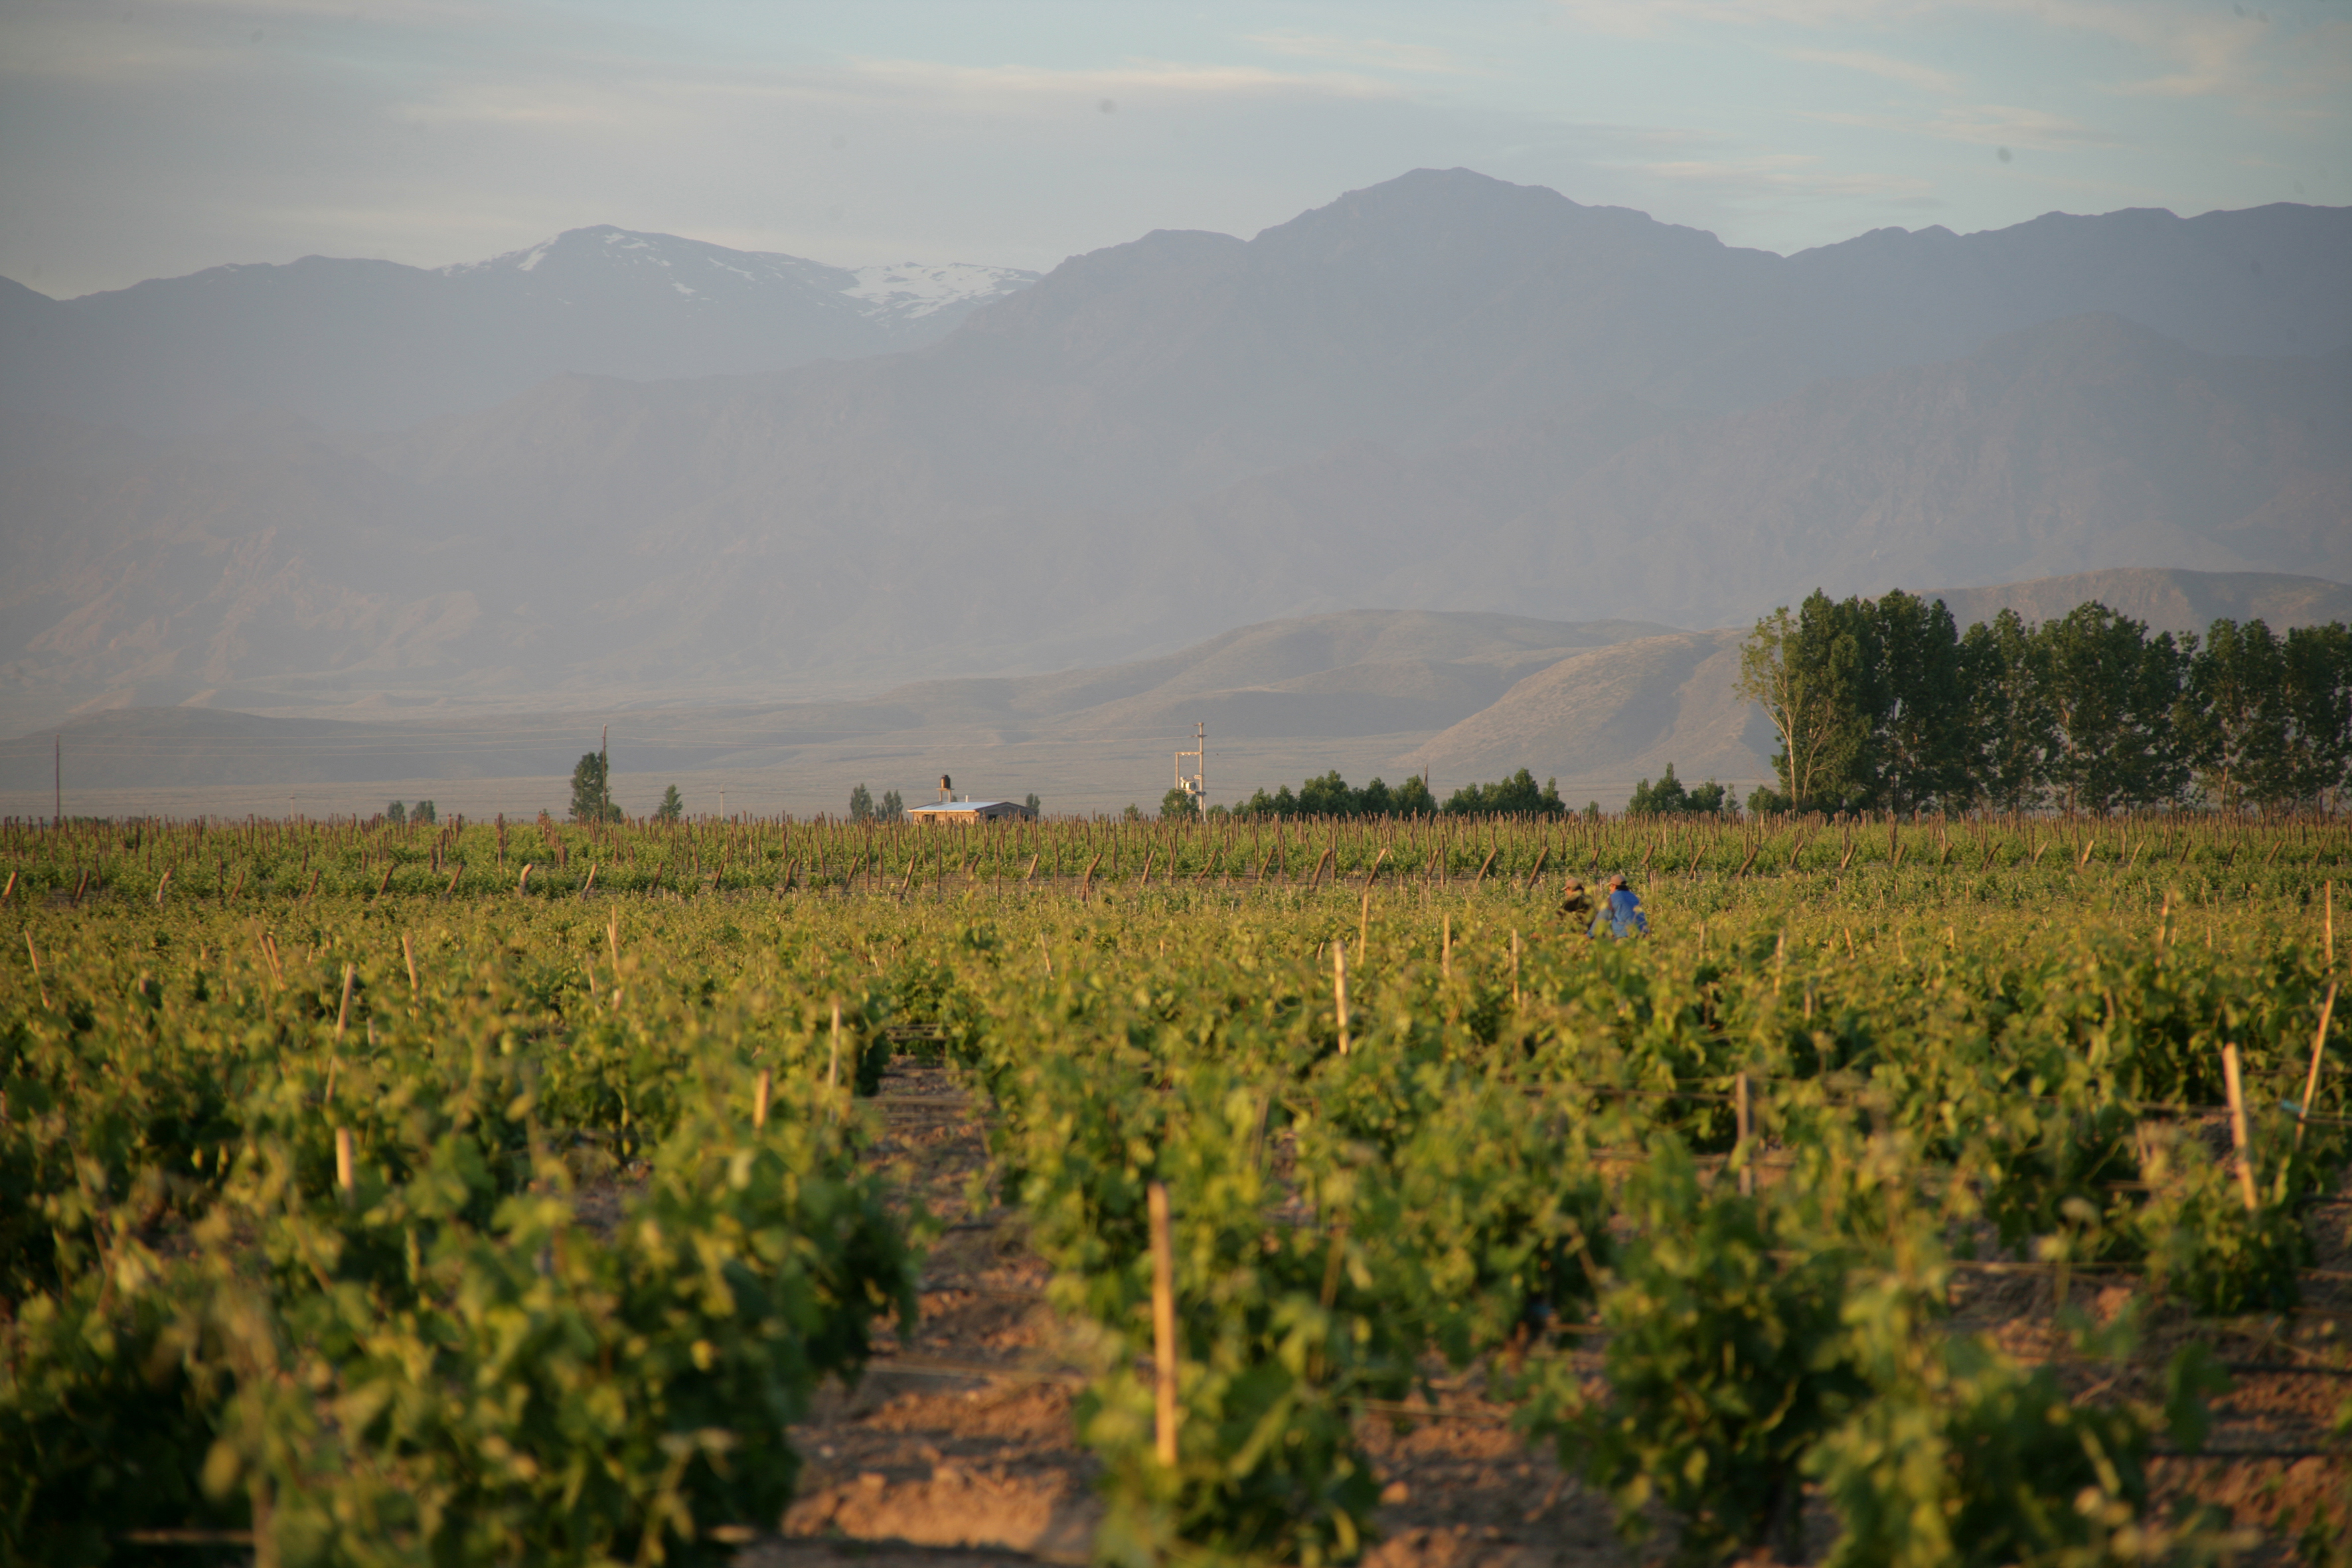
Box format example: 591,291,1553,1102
0,0,2352,299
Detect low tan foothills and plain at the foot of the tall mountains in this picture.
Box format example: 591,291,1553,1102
0,572,2352,816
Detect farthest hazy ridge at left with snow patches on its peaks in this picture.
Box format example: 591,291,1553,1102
0,226,1035,435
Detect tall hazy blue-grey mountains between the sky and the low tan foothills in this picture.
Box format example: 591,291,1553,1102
0,169,2352,809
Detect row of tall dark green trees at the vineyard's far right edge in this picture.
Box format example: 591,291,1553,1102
1738,590,2352,811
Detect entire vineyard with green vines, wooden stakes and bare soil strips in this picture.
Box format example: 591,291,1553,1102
0,813,2352,1565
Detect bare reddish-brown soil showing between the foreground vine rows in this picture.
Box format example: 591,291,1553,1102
739,1058,2352,1568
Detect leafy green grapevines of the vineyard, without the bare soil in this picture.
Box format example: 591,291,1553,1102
0,823,2352,1563
